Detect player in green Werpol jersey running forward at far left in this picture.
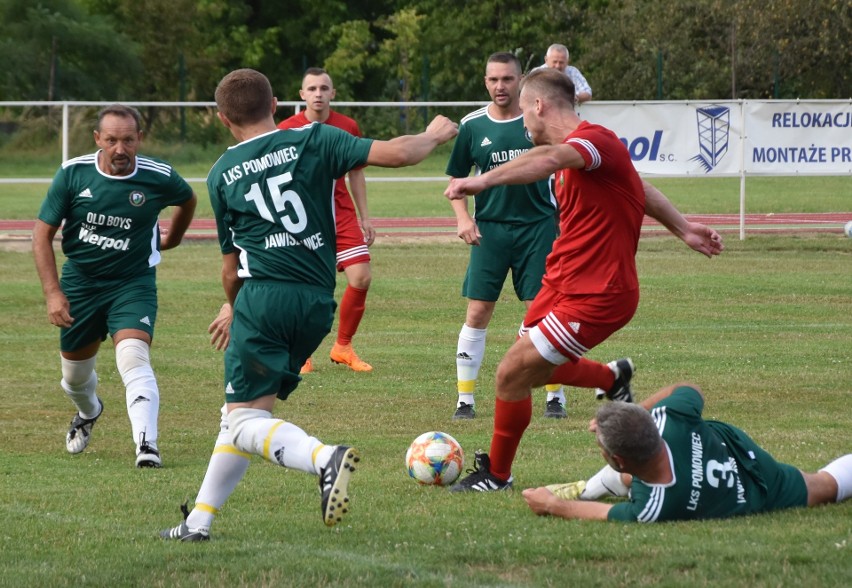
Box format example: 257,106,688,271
33,104,196,467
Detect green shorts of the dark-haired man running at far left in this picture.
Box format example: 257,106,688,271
59,264,157,351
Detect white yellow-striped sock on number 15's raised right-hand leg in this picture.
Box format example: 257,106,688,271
228,408,333,474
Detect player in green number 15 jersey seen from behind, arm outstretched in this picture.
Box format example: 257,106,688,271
160,69,458,541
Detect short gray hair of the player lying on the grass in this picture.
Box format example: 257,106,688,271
597,402,663,464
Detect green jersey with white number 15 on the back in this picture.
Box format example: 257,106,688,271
207,124,372,291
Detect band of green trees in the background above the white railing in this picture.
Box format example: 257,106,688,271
0,0,852,125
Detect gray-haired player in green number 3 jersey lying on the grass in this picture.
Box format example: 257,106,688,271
523,384,852,523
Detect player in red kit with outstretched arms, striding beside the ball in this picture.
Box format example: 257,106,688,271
445,69,723,492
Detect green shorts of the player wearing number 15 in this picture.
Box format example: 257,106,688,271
225,279,337,402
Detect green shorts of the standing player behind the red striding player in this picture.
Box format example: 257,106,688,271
462,216,556,302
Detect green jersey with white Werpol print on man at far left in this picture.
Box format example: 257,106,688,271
38,151,192,279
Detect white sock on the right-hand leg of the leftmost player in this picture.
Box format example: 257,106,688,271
115,339,160,452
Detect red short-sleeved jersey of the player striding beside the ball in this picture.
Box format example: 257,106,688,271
542,121,645,295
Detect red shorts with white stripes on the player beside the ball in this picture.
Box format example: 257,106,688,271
519,285,639,365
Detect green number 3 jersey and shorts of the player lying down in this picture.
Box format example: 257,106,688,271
607,386,808,523
